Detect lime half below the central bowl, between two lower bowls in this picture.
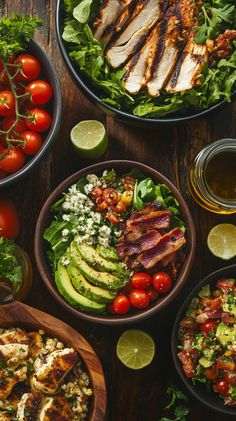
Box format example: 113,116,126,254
116,329,155,370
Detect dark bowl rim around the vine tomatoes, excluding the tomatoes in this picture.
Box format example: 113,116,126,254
0,41,62,188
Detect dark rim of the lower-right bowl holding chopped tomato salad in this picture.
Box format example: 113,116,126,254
171,264,236,416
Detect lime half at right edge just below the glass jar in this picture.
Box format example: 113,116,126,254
207,224,236,260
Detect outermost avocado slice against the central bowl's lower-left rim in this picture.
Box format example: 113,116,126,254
55,261,106,313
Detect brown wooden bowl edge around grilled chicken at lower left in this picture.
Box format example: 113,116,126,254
0,301,107,421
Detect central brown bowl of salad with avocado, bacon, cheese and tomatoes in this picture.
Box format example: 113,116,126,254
35,160,195,324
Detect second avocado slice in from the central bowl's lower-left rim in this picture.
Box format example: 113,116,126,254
67,263,116,303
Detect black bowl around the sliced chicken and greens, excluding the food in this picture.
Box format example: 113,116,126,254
56,0,236,127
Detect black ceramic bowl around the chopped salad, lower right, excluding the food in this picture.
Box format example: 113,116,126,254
171,265,236,419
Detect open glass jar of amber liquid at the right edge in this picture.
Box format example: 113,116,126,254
188,139,236,214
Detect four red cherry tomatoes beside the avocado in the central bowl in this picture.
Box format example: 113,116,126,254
108,272,172,314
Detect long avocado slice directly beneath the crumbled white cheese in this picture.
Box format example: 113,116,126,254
74,242,124,273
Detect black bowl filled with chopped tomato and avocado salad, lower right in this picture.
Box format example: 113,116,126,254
171,265,236,417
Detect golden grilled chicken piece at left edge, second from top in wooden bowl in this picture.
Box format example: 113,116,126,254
0,344,29,369
